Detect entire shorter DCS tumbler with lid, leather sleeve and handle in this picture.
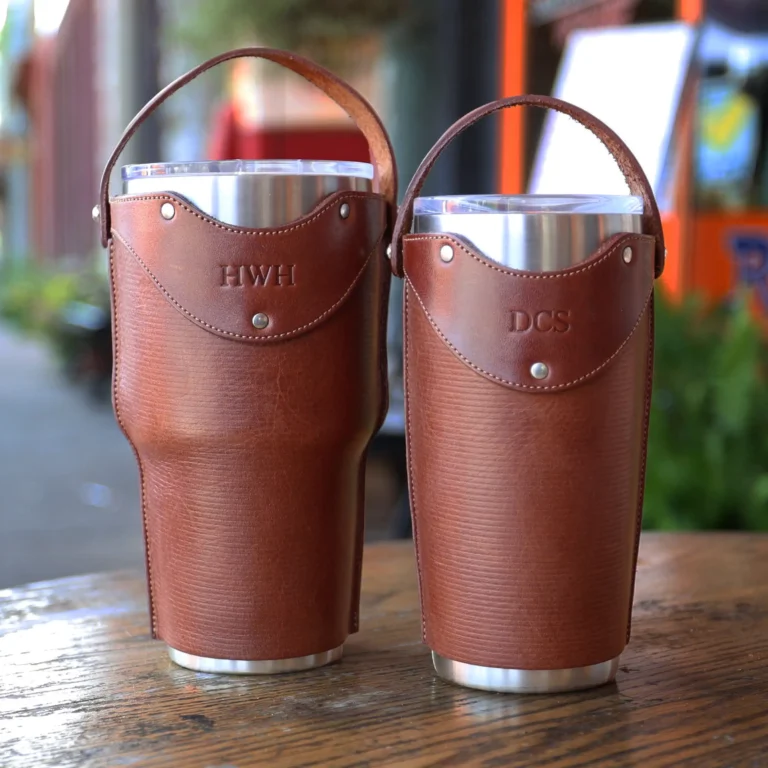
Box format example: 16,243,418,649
390,95,666,693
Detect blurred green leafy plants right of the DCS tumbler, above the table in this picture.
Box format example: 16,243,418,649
644,295,768,530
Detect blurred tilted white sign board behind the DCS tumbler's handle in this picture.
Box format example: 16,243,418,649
528,23,696,209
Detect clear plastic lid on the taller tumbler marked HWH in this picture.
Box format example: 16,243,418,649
122,160,373,181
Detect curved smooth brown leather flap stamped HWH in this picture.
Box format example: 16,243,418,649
112,192,386,342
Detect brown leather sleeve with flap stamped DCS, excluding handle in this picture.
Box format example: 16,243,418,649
403,234,655,669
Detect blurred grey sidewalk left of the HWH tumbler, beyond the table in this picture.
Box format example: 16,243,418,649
0,326,144,589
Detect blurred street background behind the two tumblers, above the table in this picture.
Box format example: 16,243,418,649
0,0,768,588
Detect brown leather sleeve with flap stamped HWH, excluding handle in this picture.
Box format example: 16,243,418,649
110,192,389,659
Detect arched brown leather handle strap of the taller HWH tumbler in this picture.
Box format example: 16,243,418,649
99,47,397,248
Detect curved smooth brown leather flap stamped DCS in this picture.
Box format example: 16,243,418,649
404,234,655,392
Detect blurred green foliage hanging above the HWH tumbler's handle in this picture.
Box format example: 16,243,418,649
179,0,409,65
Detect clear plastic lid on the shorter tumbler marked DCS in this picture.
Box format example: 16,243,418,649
413,195,643,216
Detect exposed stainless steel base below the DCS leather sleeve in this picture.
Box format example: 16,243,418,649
432,651,619,693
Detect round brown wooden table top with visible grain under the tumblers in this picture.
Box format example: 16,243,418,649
0,534,768,768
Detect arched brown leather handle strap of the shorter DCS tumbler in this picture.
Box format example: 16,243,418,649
391,96,666,277
